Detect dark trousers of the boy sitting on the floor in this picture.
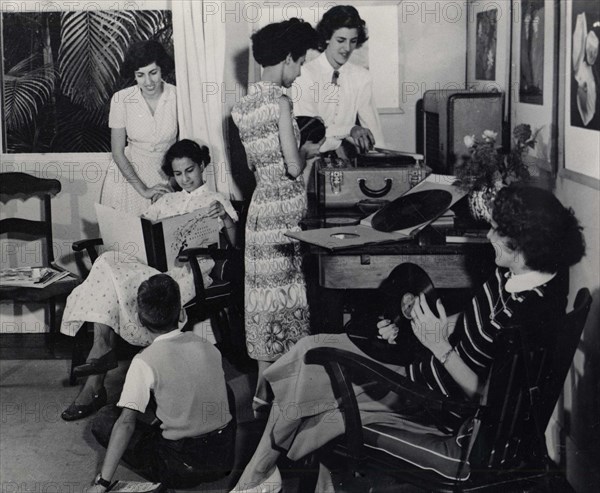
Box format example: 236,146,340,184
92,404,235,488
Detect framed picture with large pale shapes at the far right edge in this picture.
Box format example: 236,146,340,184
559,0,600,188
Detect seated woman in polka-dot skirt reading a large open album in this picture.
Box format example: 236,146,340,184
60,139,238,421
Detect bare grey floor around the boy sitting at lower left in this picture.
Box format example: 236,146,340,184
0,346,418,493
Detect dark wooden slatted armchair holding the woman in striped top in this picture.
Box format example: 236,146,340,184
300,288,591,492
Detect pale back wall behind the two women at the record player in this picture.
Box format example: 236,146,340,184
241,0,468,152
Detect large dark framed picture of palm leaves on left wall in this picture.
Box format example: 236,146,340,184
0,10,174,154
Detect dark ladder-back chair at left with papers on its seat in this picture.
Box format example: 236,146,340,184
0,172,79,342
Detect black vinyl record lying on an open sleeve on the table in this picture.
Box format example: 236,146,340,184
371,190,452,233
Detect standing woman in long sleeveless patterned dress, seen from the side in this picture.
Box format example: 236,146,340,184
232,18,320,410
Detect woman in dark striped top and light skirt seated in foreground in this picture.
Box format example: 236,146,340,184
234,185,585,493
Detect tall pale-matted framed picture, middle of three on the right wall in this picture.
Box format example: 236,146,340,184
511,0,560,177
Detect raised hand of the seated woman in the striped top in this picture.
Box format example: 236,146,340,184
411,293,451,359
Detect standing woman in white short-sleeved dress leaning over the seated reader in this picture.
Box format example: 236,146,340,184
100,41,177,214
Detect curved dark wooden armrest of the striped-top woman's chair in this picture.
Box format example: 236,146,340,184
304,347,481,414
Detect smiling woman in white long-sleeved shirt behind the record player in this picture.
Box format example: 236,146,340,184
296,5,383,152
